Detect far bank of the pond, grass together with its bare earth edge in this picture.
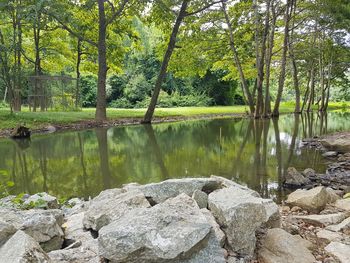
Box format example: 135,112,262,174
0,103,350,137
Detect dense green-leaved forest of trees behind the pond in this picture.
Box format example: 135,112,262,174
0,0,350,123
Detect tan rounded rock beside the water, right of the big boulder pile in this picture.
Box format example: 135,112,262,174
286,186,330,213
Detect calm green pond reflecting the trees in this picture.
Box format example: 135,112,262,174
0,113,350,201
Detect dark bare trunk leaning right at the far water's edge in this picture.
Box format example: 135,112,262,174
142,0,190,123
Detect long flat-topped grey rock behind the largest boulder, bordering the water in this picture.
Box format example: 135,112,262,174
124,178,220,204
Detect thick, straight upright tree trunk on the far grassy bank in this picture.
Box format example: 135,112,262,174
95,0,107,122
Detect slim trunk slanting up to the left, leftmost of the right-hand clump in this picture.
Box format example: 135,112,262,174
221,1,255,114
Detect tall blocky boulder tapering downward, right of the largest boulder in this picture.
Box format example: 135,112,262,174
208,187,278,256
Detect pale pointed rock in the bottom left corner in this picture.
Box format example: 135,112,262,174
0,230,51,263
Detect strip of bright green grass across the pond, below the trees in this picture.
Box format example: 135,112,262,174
0,102,350,130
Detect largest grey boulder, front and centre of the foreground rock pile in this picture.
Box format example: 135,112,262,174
98,194,225,263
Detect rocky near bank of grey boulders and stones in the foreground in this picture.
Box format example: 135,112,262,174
0,176,350,263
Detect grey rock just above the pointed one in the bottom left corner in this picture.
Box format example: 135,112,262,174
21,210,63,252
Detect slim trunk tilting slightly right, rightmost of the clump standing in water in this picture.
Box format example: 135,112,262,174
272,0,291,117
